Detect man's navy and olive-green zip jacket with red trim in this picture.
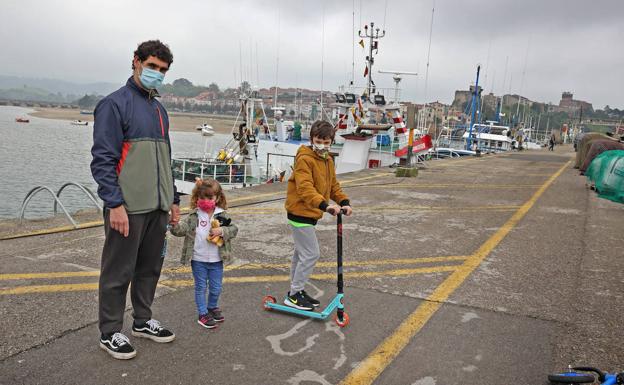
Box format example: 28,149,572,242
91,77,180,214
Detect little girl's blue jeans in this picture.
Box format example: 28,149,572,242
191,261,223,315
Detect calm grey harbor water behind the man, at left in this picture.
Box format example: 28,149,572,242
0,106,229,219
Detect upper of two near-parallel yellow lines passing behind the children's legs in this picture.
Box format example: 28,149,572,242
0,256,468,281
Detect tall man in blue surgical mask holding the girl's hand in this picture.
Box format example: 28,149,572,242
91,40,180,359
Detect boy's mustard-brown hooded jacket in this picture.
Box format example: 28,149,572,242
285,146,349,225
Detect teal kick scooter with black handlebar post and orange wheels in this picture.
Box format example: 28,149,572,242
262,210,349,327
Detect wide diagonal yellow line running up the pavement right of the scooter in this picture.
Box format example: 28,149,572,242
340,162,571,385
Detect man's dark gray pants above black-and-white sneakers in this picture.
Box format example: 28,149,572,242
98,209,168,334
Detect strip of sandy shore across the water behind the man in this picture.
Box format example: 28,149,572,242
29,108,234,134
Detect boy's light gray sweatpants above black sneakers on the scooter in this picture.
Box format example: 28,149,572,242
290,225,321,294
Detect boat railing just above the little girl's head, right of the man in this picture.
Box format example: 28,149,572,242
171,159,260,187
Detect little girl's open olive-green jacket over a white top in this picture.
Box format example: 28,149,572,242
171,209,238,265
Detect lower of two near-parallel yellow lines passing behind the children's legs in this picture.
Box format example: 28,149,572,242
0,266,458,295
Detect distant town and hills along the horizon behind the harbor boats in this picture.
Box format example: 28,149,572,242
0,78,624,132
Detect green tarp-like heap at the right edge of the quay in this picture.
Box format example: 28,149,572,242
585,150,624,203
